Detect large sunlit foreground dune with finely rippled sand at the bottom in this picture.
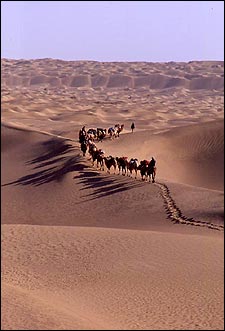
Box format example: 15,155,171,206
2,225,223,330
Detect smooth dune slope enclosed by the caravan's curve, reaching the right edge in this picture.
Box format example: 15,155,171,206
102,121,224,190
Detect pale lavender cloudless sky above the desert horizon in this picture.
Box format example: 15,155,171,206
1,1,224,62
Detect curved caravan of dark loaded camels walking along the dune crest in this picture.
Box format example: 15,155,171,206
79,124,156,183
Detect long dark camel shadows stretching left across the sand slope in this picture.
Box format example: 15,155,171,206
2,138,141,203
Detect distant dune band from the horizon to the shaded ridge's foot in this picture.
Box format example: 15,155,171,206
2,59,224,90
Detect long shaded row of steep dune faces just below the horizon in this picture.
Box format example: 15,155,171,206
3,74,224,90
